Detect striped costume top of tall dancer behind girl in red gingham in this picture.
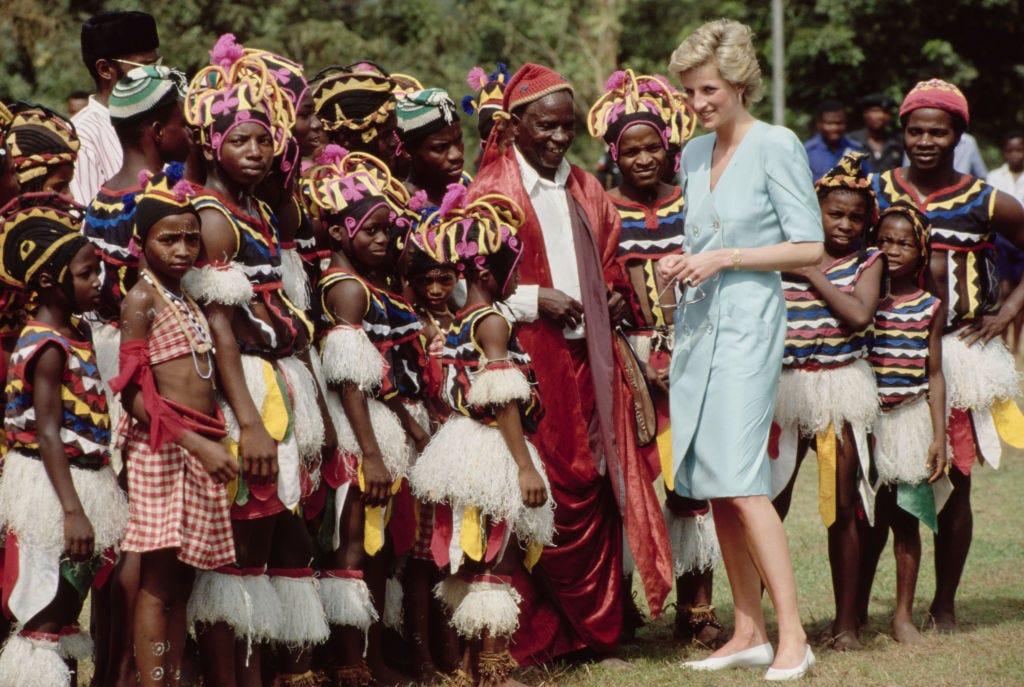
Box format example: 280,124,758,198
193,188,313,357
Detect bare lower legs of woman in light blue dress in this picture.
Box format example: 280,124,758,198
712,496,807,669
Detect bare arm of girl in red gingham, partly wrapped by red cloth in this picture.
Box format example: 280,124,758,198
121,288,239,484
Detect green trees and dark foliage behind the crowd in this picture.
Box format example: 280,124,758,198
0,0,1024,163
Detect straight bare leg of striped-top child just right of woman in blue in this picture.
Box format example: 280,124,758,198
828,424,863,651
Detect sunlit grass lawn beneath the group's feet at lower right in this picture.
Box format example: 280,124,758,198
521,449,1024,687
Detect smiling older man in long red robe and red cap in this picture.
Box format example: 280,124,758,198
470,65,672,663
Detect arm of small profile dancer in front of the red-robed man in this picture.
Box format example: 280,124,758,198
476,315,548,508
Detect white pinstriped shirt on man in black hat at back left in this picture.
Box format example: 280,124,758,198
71,95,124,206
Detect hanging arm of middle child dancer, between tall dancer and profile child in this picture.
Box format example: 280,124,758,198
327,280,391,506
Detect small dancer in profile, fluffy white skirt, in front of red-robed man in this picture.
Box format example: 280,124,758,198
411,187,554,687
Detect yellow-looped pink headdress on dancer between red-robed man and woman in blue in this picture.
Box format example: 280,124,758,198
587,70,695,160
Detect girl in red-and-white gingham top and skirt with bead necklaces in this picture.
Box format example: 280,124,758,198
111,164,238,687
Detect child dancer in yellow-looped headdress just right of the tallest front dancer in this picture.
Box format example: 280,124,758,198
306,144,409,687
